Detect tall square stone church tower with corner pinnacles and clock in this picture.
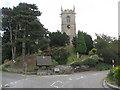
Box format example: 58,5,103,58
61,7,76,44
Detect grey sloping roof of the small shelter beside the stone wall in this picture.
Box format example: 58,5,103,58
36,56,52,66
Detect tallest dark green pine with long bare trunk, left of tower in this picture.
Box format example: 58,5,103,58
13,3,41,62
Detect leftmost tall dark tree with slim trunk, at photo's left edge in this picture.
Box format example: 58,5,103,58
2,8,17,60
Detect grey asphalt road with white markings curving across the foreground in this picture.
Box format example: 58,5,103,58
2,71,108,88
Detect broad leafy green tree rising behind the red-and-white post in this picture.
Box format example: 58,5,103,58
94,34,118,64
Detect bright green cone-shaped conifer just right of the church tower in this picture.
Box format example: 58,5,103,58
76,31,87,54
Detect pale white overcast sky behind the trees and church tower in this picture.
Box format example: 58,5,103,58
0,0,119,39
